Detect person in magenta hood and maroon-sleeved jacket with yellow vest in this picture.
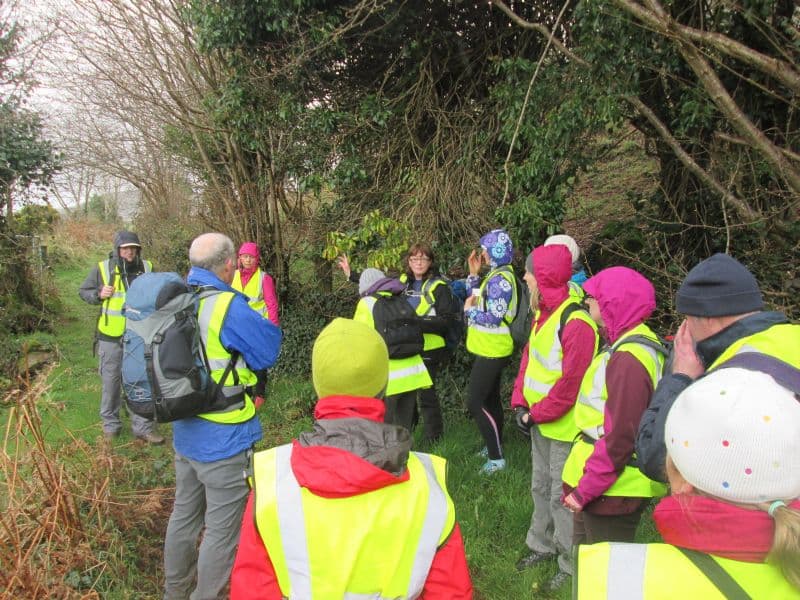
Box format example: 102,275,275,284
561,267,667,544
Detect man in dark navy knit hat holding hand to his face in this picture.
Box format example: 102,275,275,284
636,253,800,481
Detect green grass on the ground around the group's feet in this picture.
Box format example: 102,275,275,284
6,254,657,600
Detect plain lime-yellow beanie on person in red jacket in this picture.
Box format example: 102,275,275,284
311,318,389,398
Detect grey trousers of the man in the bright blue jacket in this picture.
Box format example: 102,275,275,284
164,450,250,600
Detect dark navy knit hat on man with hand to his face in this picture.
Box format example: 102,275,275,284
675,253,764,317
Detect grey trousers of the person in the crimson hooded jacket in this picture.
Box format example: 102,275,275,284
525,426,573,575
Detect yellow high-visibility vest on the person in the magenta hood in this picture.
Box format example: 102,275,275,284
561,323,667,498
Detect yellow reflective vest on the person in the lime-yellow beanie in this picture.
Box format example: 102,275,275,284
253,445,455,600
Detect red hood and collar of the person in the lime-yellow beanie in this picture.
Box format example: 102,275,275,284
291,396,409,498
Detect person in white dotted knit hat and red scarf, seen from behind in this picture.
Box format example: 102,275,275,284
573,367,800,600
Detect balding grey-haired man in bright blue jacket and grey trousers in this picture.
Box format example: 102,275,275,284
164,233,282,600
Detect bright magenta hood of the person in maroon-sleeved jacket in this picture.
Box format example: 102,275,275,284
583,267,656,344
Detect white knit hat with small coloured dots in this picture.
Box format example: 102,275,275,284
665,368,800,504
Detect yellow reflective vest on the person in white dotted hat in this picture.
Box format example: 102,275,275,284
573,542,800,600
